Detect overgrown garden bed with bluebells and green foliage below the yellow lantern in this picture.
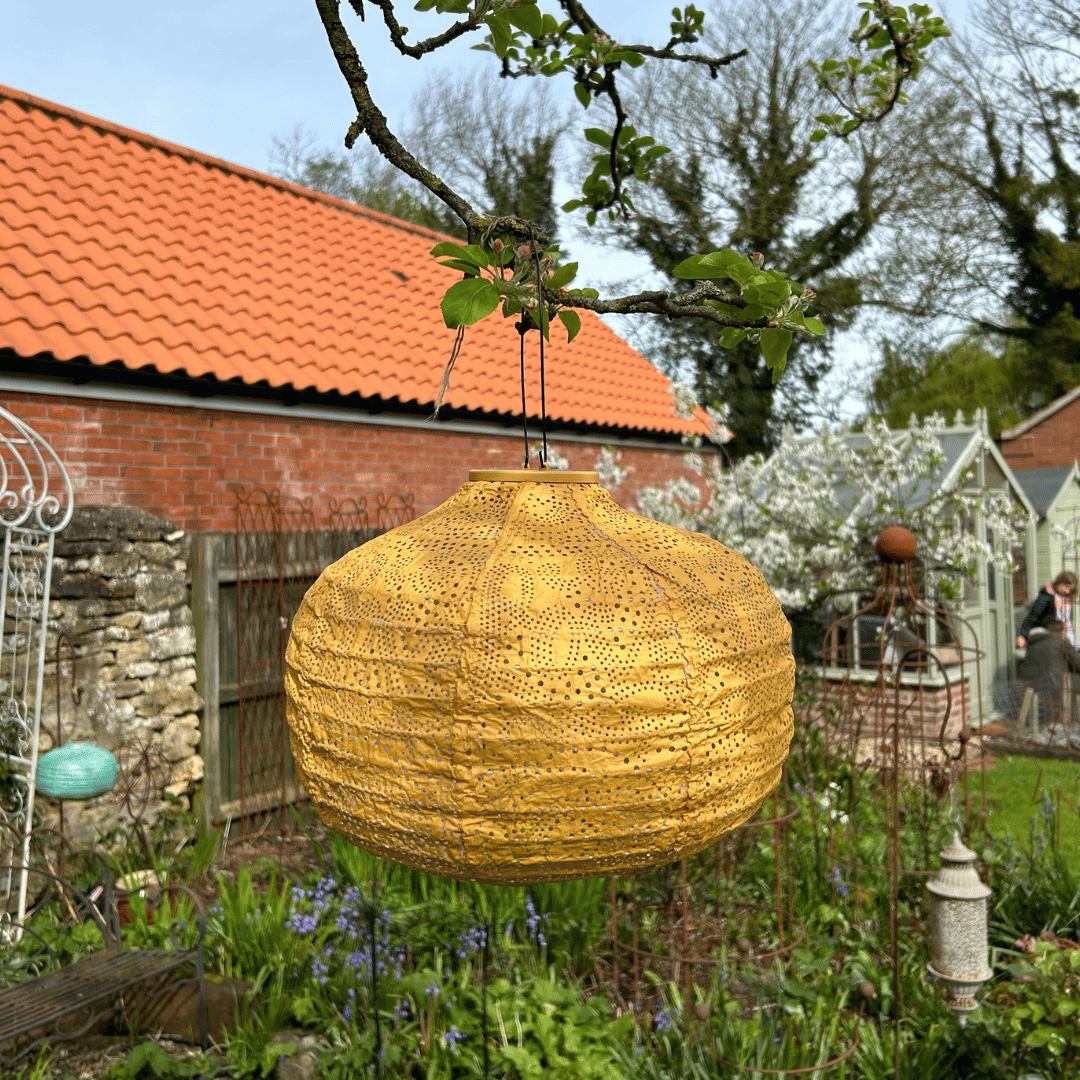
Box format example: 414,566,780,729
6,682,1080,1080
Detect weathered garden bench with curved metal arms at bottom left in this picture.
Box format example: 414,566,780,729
0,842,207,1065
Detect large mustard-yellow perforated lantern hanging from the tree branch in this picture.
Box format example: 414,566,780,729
286,471,795,882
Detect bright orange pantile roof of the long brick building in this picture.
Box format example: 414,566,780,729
0,86,704,433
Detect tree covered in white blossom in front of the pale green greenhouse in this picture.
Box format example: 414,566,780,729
638,416,1027,611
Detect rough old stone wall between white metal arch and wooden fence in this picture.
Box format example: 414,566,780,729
40,505,203,843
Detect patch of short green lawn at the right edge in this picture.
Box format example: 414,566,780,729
972,755,1080,870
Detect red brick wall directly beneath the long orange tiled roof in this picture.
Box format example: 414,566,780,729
3,393,708,532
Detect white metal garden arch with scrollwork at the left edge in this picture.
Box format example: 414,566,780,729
0,407,72,923
